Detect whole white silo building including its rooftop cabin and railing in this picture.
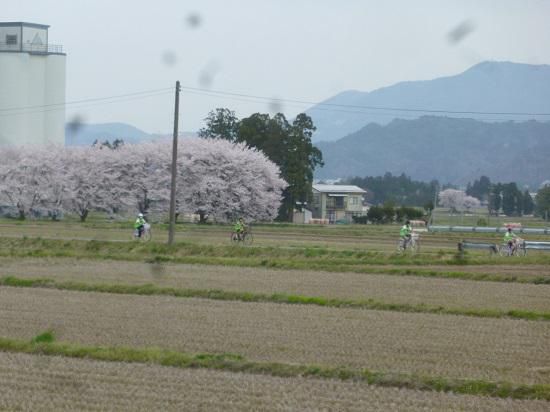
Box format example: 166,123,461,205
0,22,66,145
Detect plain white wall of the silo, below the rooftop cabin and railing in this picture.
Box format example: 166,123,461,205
0,52,65,145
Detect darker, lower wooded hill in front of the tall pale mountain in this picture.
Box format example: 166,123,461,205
315,116,550,187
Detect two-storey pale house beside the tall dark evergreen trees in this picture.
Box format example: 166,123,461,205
312,184,367,223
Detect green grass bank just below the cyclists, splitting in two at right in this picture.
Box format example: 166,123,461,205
0,238,550,284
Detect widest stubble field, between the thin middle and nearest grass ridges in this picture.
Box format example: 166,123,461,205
0,287,550,384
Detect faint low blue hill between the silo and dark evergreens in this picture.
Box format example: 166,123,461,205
65,123,196,146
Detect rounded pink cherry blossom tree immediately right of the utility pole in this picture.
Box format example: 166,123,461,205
177,139,286,221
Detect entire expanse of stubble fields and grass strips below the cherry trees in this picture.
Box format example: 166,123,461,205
0,219,550,411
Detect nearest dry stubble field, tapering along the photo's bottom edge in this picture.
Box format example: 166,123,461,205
0,353,548,412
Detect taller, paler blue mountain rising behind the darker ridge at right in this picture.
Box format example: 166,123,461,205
307,62,550,142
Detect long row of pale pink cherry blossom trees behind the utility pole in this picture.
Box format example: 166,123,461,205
0,139,292,221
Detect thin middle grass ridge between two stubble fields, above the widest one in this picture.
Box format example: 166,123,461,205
0,276,550,321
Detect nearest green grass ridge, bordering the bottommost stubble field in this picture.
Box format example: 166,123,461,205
0,337,550,401
